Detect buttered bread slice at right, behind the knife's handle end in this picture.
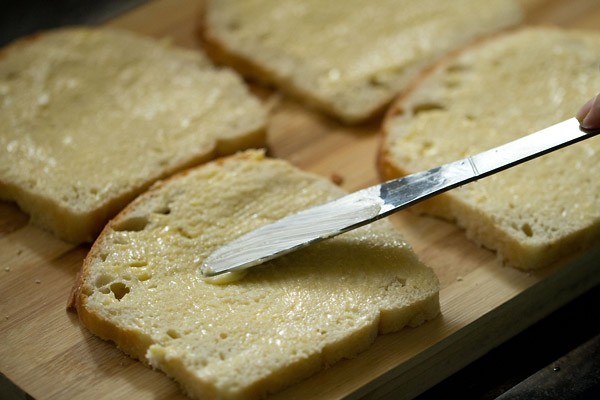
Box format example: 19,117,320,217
380,27,600,269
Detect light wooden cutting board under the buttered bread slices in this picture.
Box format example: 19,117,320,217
0,0,600,399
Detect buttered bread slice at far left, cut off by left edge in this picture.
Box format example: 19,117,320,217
0,28,266,242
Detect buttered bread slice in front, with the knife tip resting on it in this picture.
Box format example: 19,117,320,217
72,151,439,399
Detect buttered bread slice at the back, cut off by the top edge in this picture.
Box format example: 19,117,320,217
201,0,522,123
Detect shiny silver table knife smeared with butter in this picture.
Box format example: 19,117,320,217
200,118,600,277
